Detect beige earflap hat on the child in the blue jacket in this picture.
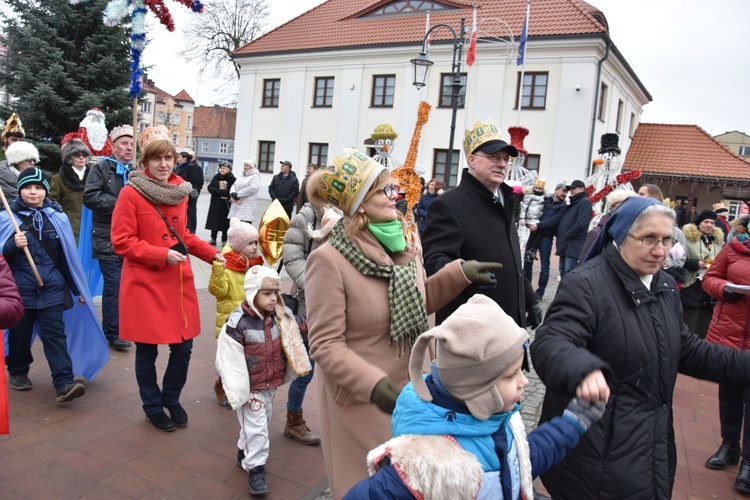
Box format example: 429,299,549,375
409,295,529,420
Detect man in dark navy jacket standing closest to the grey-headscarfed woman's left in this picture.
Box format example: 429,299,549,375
556,180,592,278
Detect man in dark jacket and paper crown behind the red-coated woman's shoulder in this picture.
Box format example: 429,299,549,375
83,125,133,351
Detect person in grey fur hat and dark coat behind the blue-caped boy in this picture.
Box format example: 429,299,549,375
49,139,91,243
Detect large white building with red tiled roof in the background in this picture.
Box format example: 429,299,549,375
234,0,651,190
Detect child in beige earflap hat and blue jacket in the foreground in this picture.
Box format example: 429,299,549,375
344,295,604,499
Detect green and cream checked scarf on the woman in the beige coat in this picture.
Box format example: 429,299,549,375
328,220,430,356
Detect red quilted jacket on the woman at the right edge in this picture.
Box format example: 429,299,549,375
703,243,750,351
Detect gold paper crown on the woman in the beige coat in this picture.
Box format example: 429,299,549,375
318,148,385,216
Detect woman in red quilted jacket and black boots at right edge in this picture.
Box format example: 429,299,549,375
703,215,750,493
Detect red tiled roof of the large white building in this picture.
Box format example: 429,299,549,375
234,0,609,55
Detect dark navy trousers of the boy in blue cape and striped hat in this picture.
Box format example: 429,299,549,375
5,304,73,389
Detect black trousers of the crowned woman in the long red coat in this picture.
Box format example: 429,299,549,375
135,339,193,415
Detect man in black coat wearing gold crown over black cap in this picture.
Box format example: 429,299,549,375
422,120,542,328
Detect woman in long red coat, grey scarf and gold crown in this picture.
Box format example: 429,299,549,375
111,126,224,432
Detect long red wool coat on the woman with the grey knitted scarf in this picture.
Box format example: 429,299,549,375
111,174,217,344
